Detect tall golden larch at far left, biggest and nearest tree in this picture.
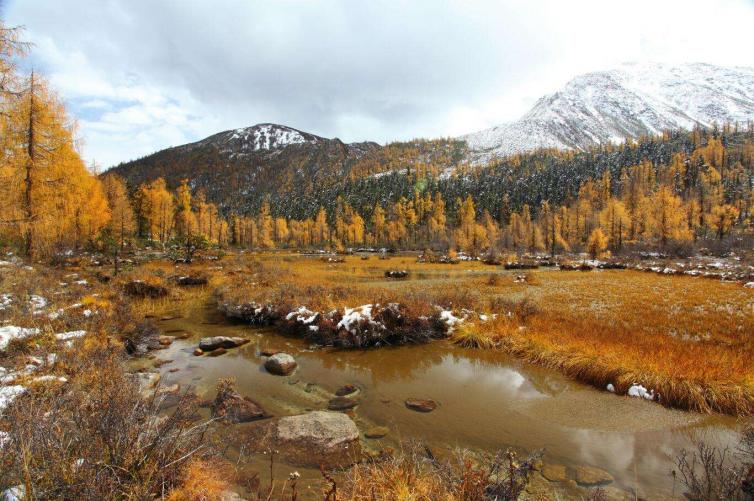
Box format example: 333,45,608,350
0,73,109,257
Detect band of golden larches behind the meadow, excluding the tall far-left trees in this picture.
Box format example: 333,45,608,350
126,131,754,255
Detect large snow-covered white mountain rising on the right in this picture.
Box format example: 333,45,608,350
460,63,754,162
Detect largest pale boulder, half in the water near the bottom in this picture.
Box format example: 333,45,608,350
241,411,361,469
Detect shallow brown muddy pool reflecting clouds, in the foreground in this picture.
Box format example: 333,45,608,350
144,301,737,498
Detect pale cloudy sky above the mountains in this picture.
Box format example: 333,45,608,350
0,0,754,168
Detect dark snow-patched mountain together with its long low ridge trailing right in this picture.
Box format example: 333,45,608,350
108,123,468,213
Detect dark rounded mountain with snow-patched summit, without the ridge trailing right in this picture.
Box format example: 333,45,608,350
108,123,380,210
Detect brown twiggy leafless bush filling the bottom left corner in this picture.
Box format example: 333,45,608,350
0,340,210,499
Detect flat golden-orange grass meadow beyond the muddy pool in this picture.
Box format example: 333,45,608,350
210,254,754,415
